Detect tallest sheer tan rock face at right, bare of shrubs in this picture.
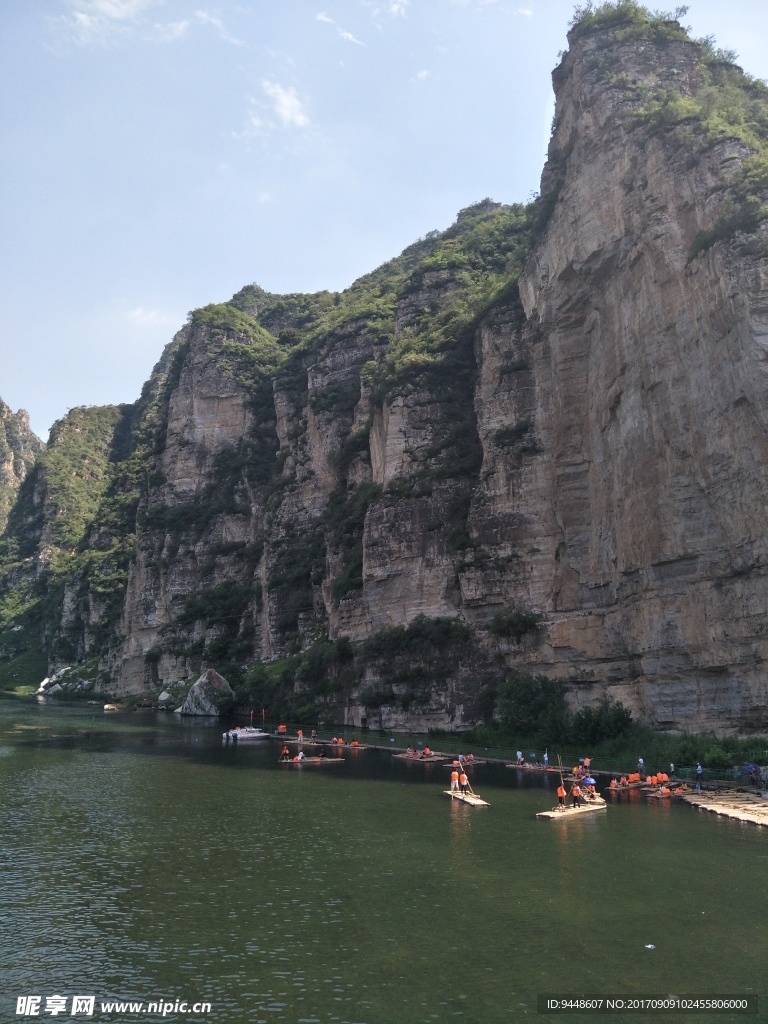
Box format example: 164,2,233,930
501,19,768,731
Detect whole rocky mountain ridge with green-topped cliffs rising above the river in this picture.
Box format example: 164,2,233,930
0,2,768,732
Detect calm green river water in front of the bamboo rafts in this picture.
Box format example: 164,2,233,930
0,699,768,1024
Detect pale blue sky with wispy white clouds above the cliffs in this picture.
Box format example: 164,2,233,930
0,0,768,440
